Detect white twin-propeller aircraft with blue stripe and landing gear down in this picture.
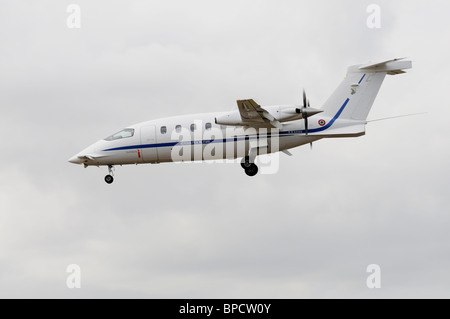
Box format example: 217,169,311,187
69,59,412,184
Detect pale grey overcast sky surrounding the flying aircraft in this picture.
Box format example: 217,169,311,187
0,0,450,298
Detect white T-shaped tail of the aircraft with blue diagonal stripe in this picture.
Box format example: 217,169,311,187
321,59,412,131
